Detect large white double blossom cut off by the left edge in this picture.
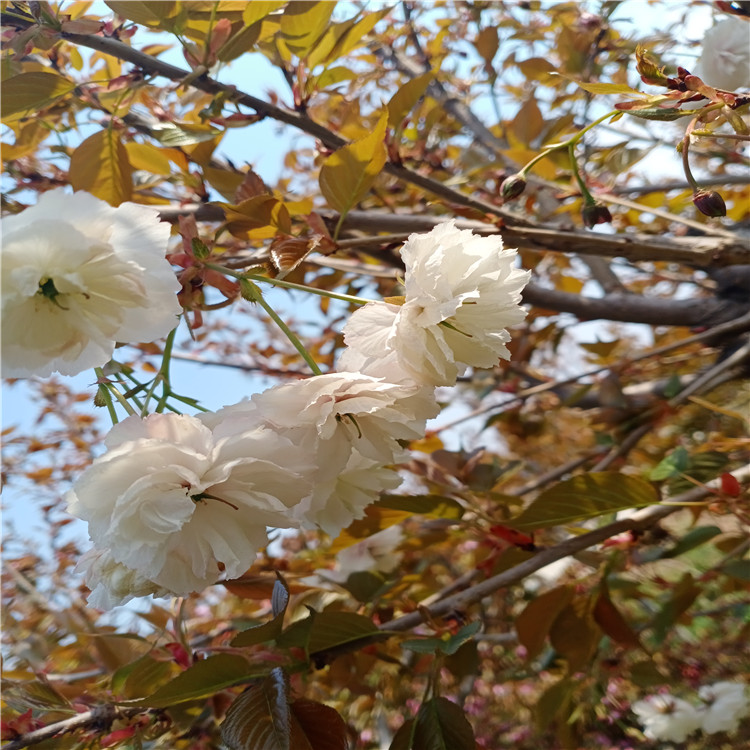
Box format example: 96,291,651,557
2,189,181,377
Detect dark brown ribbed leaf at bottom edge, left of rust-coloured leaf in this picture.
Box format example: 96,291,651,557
221,667,290,750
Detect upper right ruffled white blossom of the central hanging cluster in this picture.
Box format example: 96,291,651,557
340,221,529,386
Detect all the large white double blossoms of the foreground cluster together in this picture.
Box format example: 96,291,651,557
2,191,528,608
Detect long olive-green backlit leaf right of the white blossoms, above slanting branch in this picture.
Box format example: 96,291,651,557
508,471,659,531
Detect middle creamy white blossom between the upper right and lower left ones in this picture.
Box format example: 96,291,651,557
210,372,438,536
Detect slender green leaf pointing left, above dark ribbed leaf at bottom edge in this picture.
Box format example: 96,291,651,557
134,654,266,708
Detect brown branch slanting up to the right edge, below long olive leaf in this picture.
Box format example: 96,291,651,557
381,465,750,631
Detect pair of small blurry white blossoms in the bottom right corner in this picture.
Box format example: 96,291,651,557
632,682,750,742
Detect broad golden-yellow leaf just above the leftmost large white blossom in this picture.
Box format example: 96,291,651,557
70,130,133,206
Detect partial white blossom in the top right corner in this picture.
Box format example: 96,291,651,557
695,18,750,91
